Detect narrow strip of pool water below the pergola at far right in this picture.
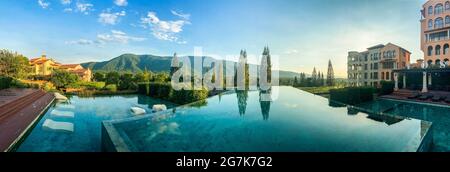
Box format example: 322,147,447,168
358,99,450,152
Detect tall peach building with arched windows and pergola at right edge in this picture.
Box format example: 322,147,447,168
395,0,450,93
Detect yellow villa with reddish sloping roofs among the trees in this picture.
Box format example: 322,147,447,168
30,55,92,81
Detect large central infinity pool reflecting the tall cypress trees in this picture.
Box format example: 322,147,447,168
103,87,429,152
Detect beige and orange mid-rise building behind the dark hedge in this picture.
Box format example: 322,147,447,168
348,43,411,86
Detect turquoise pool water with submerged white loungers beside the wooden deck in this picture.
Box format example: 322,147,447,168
17,95,178,152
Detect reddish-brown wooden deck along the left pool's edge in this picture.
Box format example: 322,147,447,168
0,89,54,151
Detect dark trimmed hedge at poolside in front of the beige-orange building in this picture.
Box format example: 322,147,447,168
330,87,375,105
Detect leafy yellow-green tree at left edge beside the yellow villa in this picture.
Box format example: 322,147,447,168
0,50,31,79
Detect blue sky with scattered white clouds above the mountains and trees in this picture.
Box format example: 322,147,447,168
0,0,425,77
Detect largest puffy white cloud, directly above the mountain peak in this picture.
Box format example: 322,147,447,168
141,12,190,43
